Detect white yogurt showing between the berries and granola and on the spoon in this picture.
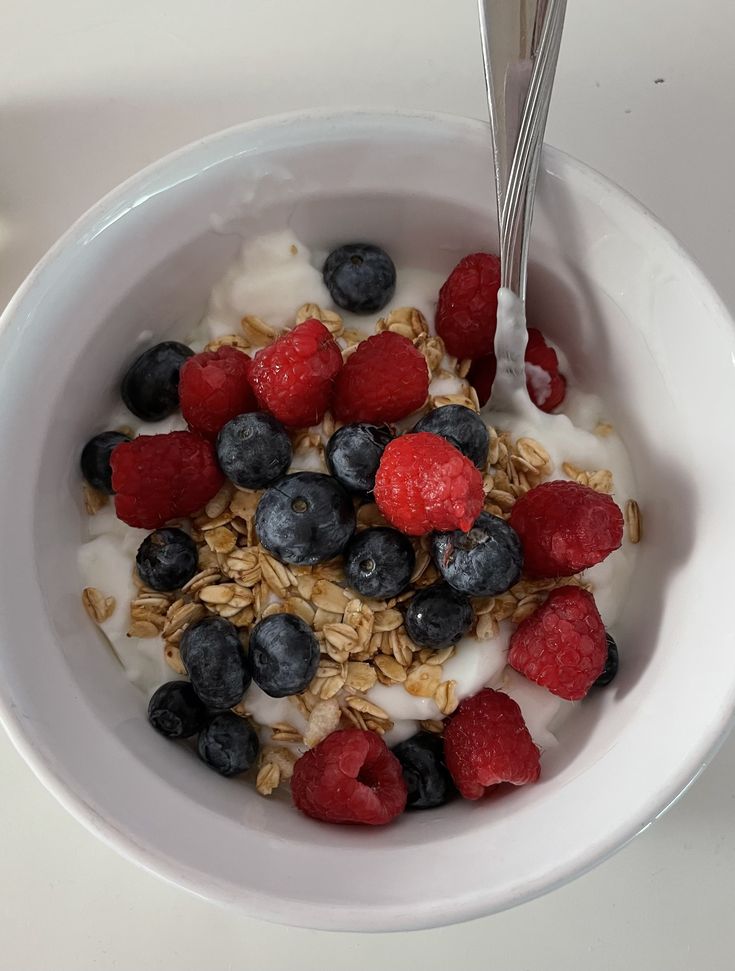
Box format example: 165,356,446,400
79,237,634,748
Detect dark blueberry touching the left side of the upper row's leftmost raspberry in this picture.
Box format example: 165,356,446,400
120,341,194,421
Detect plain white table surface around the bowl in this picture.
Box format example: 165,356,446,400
0,0,735,971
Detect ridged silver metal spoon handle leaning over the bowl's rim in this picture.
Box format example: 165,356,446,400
479,0,566,299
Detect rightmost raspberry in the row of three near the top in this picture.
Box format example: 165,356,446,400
334,330,429,424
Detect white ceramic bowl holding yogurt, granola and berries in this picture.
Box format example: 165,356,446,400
0,112,735,930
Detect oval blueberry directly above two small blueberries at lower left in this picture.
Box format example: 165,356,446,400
180,617,250,709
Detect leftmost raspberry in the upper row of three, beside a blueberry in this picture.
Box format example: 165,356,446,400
179,346,258,439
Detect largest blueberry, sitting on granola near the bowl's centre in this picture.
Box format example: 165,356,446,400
255,472,355,564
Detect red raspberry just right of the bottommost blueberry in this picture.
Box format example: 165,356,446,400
444,688,540,799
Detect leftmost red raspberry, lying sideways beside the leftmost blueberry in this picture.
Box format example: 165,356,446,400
110,432,224,529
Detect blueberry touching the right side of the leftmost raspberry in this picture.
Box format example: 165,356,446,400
217,411,293,489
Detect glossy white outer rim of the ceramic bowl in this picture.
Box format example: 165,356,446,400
0,107,735,931
